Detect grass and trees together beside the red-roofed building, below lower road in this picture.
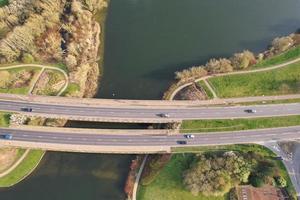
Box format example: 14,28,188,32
138,145,295,200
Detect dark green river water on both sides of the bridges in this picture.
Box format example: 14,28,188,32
0,0,300,200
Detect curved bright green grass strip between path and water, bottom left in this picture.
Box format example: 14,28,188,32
0,150,44,187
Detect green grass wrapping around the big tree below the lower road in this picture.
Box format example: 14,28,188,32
138,145,295,200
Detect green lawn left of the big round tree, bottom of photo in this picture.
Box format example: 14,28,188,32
137,154,228,200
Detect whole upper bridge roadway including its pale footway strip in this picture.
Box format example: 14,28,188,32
0,94,300,123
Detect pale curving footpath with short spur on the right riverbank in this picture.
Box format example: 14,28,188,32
170,57,300,99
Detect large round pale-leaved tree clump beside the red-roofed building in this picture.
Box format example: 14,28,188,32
183,153,250,196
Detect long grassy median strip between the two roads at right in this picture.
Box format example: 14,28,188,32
180,115,300,133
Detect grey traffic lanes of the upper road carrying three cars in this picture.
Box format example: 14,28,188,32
0,102,300,119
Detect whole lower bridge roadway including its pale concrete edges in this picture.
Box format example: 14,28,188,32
0,126,300,154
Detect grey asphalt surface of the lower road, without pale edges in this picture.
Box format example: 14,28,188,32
0,126,300,148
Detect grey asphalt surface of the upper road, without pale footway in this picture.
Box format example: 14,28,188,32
0,100,300,122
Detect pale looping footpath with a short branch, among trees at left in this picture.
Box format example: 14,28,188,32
0,64,69,96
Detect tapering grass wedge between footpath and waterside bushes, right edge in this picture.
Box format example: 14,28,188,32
251,46,300,69
